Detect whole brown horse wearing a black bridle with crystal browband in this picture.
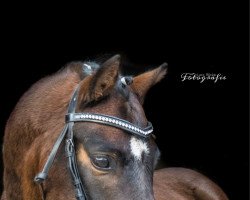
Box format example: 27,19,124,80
2,55,227,200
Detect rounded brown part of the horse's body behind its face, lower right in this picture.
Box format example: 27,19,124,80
154,167,227,200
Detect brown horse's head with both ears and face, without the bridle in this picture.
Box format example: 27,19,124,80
70,56,166,200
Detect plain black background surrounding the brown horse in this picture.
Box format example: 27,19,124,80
0,1,249,200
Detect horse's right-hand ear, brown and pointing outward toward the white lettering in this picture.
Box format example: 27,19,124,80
131,63,167,104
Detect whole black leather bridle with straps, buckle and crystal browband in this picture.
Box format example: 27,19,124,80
34,82,153,200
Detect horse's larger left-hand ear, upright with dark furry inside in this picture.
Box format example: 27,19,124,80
78,55,120,103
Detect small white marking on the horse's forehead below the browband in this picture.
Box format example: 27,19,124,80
130,137,149,160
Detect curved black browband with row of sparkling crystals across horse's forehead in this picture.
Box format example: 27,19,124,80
66,113,153,137
